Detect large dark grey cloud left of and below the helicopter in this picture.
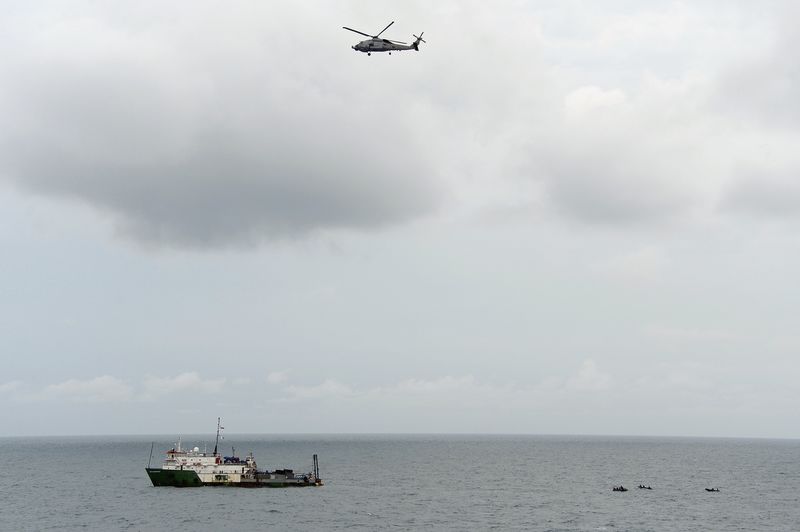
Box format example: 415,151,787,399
0,7,439,247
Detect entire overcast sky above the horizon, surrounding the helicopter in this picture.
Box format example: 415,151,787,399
0,0,800,438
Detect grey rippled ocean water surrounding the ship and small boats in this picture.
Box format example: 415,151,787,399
0,435,800,531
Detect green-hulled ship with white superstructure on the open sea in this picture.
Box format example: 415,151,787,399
145,418,323,488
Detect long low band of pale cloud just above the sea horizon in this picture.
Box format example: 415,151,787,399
10,359,797,434
